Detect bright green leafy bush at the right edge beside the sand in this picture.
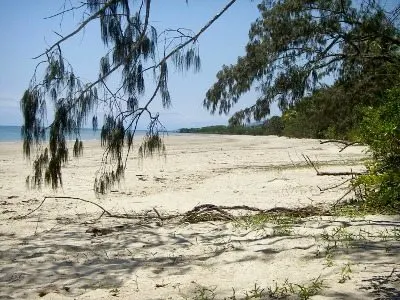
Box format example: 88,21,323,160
355,86,400,212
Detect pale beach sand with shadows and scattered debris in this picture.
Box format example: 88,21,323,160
0,135,400,299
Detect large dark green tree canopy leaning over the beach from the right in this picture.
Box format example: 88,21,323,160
204,0,400,125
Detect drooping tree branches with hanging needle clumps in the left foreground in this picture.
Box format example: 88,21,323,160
21,0,236,193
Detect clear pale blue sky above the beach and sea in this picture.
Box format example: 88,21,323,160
0,0,278,130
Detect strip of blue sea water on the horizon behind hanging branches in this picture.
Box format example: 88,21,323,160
0,126,153,142
